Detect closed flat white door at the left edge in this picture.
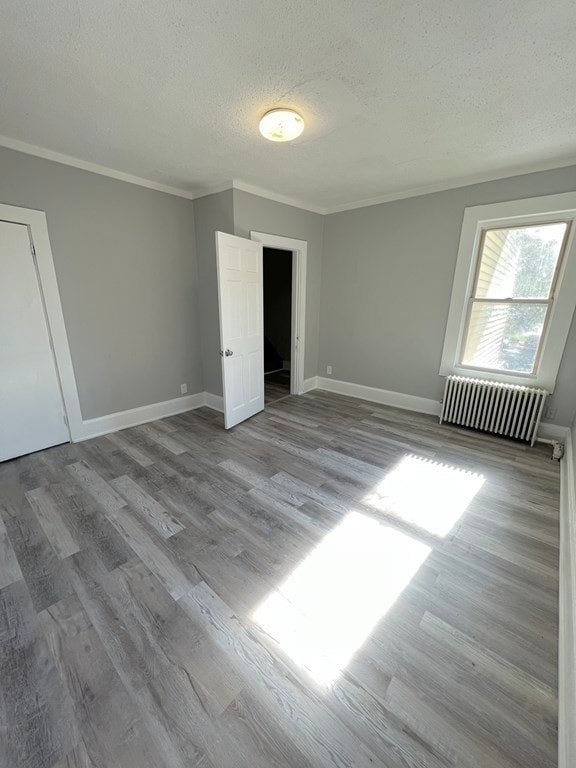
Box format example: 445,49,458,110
0,221,70,461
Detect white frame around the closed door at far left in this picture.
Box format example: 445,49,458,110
0,203,82,442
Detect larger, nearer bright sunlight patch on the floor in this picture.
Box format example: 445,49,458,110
253,512,430,685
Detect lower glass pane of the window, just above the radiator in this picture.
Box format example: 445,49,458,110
462,302,547,373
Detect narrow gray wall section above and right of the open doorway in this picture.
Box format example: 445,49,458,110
234,189,326,388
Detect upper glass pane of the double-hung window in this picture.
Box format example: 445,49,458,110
474,222,567,299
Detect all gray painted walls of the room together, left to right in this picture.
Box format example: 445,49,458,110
0,142,576,426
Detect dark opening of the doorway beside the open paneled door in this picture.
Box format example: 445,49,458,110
263,246,293,405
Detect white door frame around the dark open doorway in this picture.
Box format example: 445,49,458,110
250,231,308,395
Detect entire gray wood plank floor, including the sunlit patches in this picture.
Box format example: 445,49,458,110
0,391,559,768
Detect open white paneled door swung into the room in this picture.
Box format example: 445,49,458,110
216,232,264,429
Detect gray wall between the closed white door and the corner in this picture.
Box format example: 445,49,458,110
0,148,203,419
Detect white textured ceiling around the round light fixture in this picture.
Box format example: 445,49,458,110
0,0,576,208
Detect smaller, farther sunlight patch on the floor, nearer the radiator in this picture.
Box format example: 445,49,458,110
363,456,484,536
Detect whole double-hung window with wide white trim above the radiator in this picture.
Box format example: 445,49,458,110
440,194,576,391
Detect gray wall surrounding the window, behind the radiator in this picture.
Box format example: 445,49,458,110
319,167,576,426
